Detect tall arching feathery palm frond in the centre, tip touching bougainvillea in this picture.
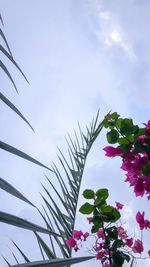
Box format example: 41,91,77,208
37,112,103,257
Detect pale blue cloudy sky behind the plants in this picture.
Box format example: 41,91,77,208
0,0,150,267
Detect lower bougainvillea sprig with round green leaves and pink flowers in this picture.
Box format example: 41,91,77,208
66,188,150,267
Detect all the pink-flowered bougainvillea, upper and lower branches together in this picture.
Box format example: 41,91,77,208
66,112,150,267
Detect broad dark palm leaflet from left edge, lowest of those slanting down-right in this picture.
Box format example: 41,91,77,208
0,211,61,236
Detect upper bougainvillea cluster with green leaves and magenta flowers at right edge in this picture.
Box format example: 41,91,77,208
103,112,150,199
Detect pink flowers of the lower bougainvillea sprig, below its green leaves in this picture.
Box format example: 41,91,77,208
66,224,150,267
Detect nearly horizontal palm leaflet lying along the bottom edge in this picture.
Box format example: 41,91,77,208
12,256,95,267
